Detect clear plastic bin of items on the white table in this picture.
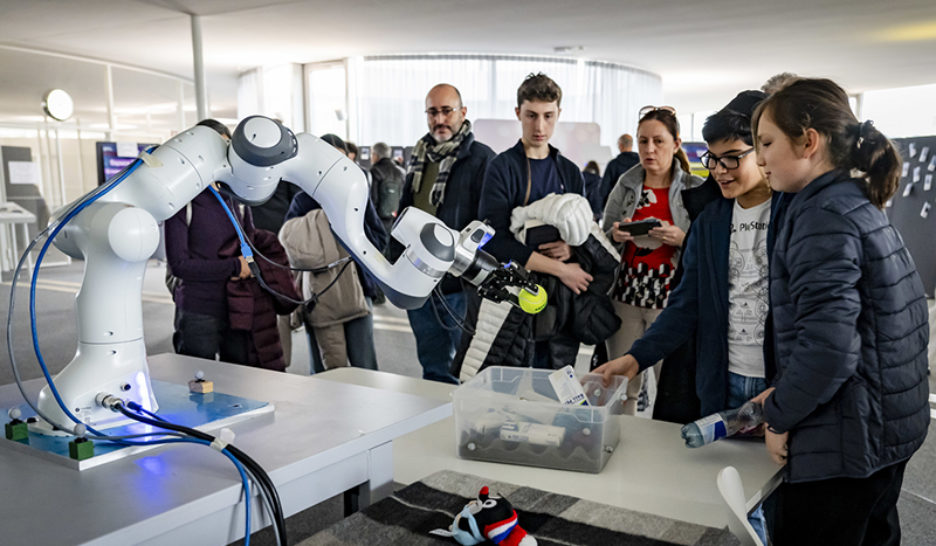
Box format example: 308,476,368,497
454,366,627,473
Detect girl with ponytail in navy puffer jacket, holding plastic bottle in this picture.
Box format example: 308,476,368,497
754,79,929,546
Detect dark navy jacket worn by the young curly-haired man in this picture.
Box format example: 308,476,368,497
478,141,585,266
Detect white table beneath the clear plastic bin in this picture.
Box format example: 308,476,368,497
321,368,781,527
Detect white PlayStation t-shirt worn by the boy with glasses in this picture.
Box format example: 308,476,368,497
728,199,771,377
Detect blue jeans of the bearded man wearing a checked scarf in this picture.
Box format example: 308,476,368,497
406,292,466,385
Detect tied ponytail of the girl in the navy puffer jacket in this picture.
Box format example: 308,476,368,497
849,120,900,208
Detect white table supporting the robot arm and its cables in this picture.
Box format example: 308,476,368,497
0,354,451,546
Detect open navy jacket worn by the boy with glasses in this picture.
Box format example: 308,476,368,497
624,194,784,415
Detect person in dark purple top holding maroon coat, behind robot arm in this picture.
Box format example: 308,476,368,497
165,119,254,364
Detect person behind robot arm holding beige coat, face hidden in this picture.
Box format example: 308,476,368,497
280,134,388,373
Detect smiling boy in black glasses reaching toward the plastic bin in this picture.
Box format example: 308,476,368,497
595,91,784,544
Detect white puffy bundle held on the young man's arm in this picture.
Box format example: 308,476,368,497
510,193,595,246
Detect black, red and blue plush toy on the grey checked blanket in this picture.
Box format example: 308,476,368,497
430,486,536,546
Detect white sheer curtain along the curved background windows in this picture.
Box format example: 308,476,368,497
245,55,663,150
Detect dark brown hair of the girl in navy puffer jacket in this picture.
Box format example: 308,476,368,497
752,78,901,209
